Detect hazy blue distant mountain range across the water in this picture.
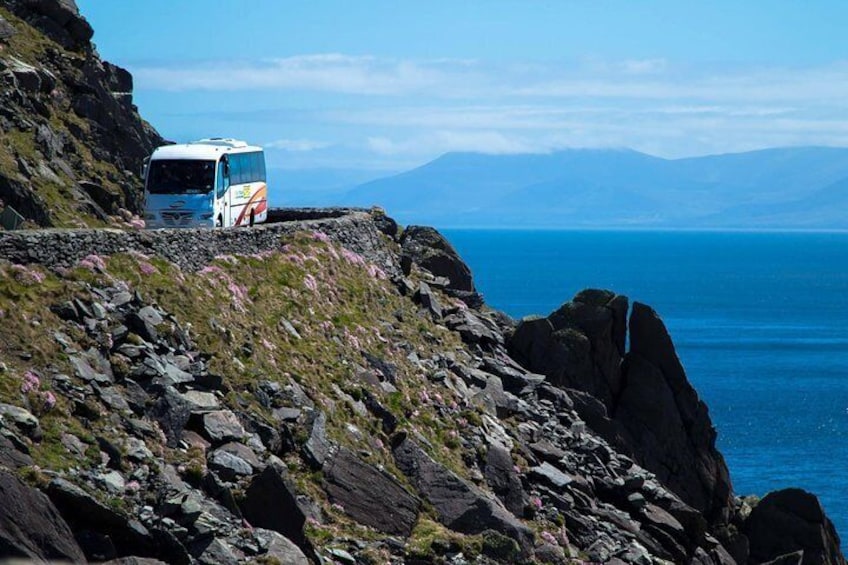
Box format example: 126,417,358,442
332,147,848,229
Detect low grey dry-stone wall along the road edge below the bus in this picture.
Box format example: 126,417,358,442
0,208,400,276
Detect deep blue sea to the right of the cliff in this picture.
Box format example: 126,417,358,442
444,230,848,542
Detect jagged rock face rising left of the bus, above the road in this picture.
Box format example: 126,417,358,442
0,0,163,226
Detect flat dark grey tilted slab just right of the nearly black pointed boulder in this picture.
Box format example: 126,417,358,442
324,448,421,537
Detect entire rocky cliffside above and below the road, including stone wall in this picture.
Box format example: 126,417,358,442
0,0,845,565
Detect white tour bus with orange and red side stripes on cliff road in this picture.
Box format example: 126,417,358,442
144,137,268,228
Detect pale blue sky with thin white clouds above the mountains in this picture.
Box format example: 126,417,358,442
77,0,848,171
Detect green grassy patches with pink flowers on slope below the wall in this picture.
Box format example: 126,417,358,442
0,234,548,553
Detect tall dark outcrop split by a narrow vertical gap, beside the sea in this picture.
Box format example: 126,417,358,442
509,290,731,524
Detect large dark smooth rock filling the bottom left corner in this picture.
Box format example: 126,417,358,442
0,470,85,563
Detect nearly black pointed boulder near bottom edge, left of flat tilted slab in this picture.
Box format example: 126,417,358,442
241,465,314,555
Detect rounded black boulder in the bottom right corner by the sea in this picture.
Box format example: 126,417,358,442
743,488,845,565
